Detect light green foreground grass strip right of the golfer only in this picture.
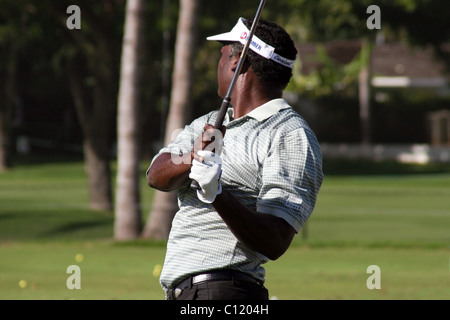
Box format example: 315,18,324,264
266,247,450,300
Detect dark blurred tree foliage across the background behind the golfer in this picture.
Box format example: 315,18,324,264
0,0,450,165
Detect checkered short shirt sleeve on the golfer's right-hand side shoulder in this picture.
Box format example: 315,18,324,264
257,128,323,233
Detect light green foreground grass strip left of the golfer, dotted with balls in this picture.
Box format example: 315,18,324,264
0,240,165,300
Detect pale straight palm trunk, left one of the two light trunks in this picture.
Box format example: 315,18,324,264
114,0,144,240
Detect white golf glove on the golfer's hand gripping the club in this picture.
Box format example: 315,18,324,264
189,150,222,203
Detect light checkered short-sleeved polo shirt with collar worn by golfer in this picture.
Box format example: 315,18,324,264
152,99,323,290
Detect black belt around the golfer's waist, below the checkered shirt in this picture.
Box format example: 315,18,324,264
168,270,264,300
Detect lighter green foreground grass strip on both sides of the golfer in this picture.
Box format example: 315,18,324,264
0,241,450,300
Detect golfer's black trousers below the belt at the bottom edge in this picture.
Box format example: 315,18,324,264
177,280,269,300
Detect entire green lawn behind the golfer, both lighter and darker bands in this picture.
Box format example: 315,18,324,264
0,161,450,300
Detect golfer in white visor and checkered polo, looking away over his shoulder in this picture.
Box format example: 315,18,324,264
147,18,323,300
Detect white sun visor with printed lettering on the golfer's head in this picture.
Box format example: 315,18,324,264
206,18,295,69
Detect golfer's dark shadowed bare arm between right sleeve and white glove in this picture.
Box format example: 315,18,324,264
213,189,295,260
